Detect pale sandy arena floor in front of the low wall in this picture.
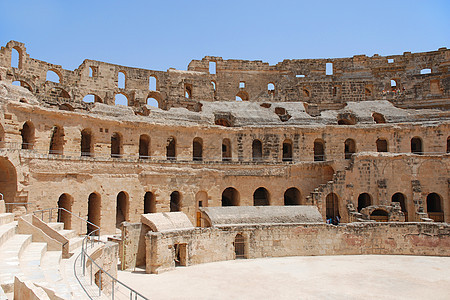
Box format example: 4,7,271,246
119,255,450,300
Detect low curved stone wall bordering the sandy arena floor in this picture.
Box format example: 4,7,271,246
146,222,450,273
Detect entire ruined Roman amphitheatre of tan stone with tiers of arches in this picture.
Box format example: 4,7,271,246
0,41,450,299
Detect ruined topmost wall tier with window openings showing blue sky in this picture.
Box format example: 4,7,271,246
0,41,450,112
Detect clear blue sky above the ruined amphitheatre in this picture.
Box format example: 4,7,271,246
0,0,450,70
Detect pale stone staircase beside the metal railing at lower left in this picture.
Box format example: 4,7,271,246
0,201,103,300
